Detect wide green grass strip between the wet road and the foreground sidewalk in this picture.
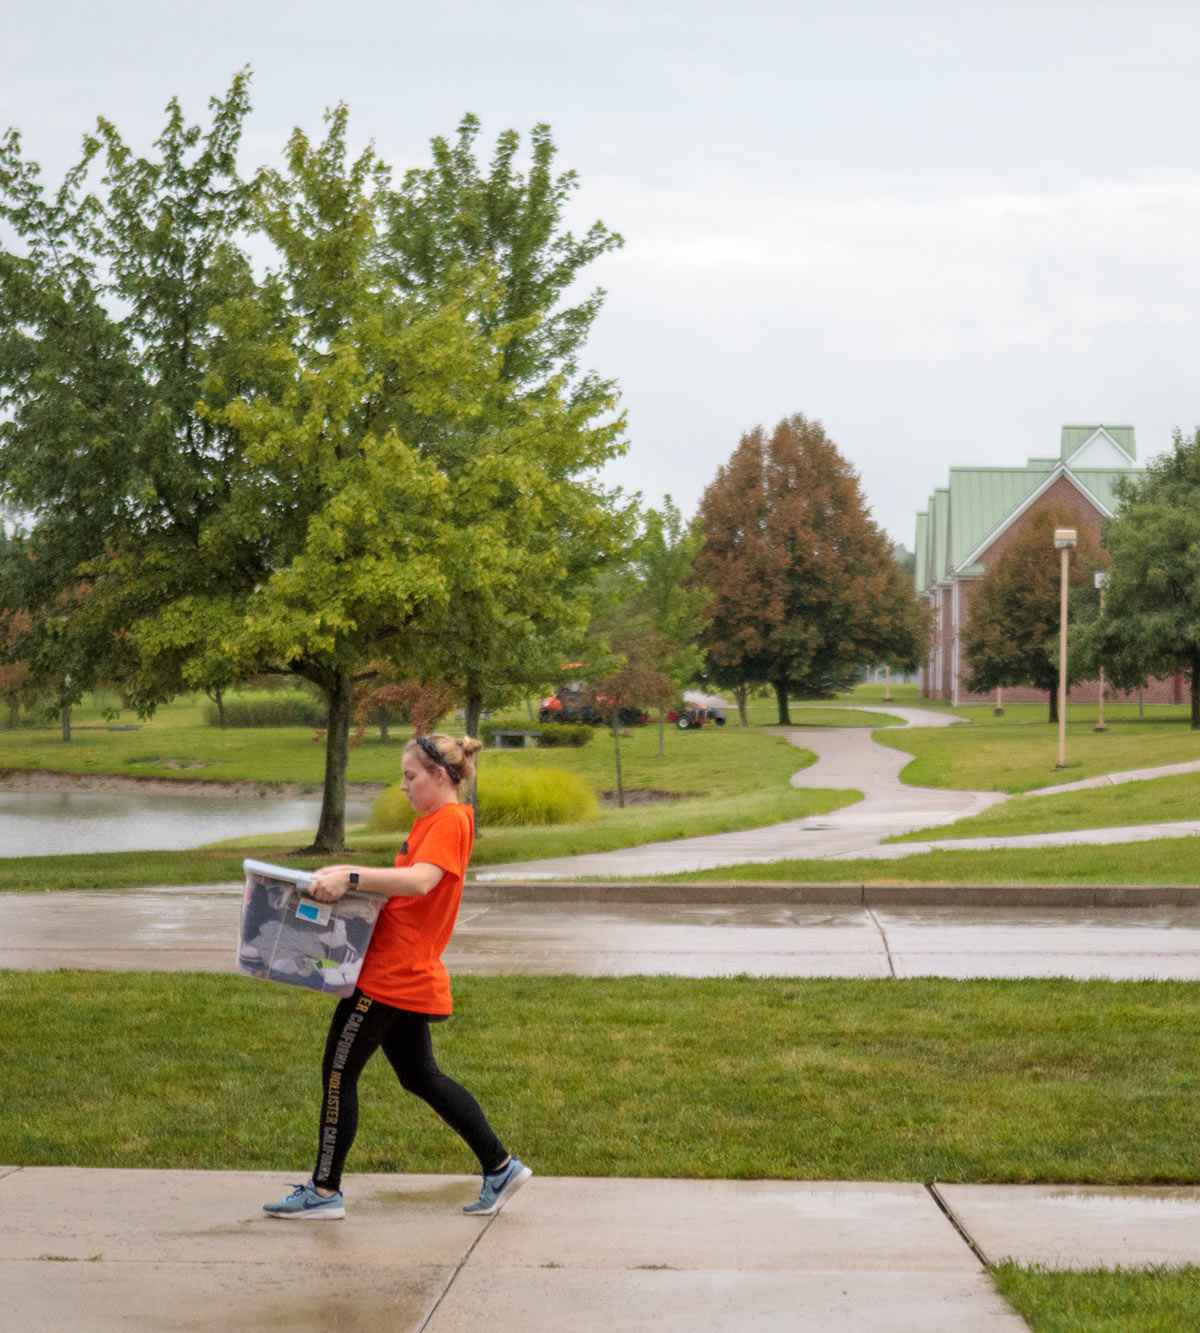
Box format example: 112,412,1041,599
9,972,1200,1184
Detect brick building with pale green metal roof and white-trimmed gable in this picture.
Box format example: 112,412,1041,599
916,425,1184,704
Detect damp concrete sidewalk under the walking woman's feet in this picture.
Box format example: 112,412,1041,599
0,1166,1200,1333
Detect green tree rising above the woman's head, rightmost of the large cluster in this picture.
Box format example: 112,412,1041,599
387,116,633,734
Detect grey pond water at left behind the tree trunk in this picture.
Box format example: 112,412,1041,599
0,792,369,856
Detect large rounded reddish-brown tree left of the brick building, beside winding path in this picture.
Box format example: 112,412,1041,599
696,415,925,724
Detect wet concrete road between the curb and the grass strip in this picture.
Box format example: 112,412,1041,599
0,885,1200,980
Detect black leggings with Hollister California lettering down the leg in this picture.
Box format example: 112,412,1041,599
312,990,508,1189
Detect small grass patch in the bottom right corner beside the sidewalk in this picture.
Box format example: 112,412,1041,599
991,1264,1200,1333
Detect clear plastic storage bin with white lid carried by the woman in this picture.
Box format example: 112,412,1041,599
237,861,384,996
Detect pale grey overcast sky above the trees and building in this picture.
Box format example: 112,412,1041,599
0,0,1200,548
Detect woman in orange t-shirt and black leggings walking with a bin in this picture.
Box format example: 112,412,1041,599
264,733,533,1218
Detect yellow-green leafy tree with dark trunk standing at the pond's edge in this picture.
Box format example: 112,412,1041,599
132,108,512,850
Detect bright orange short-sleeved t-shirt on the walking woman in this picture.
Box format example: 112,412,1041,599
359,801,475,1014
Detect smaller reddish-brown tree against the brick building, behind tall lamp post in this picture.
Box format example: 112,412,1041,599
961,505,1101,722
